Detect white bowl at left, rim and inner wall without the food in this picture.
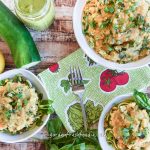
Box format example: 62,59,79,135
0,69,49,143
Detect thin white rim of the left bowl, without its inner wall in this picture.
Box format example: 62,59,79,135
0,69,50,143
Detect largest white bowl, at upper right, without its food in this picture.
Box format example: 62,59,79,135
73,0,150,70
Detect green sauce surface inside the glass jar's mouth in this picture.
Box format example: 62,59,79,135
18,0,46,15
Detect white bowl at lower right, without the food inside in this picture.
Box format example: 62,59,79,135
98,94,132,150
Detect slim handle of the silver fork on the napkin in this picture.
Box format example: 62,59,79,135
78,93,87,131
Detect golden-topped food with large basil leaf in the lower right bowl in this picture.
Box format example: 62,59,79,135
104,91,150,150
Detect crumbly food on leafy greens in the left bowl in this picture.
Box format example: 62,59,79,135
0,74,52,134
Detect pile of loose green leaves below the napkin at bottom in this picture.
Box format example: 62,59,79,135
44,118,101,150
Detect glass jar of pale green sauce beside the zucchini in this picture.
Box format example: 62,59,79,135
14,0,55,31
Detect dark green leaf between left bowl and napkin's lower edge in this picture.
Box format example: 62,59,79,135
46,118,63,134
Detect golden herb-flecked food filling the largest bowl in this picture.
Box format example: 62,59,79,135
82,0,150,64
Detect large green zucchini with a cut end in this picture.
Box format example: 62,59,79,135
0,1,41,68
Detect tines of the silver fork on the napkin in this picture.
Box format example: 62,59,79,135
70,67,83,85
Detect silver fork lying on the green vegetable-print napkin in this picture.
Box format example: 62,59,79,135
70,67,87,131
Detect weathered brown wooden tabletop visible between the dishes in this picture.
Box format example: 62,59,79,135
0,0,79,150
